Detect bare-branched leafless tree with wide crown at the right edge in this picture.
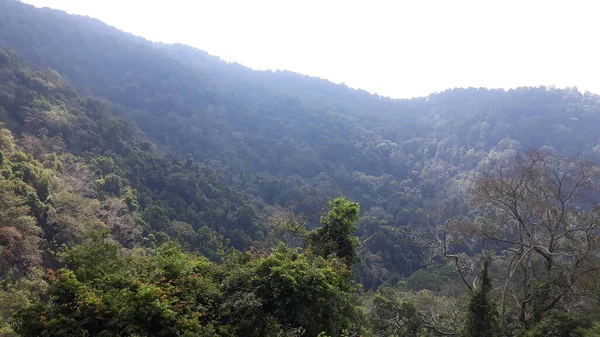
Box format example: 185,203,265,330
471,152,600,323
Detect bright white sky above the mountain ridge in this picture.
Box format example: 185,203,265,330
24,0,600,98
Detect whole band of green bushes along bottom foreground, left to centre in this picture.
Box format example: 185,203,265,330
13,236,362,337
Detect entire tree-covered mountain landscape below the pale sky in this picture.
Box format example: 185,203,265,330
0,0,600,337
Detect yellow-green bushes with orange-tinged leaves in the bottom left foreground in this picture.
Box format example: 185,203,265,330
14,240,219,336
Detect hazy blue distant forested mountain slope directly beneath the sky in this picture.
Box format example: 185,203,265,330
0,0,600,286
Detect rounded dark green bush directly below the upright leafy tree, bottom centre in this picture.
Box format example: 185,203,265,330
223,246,362,337
